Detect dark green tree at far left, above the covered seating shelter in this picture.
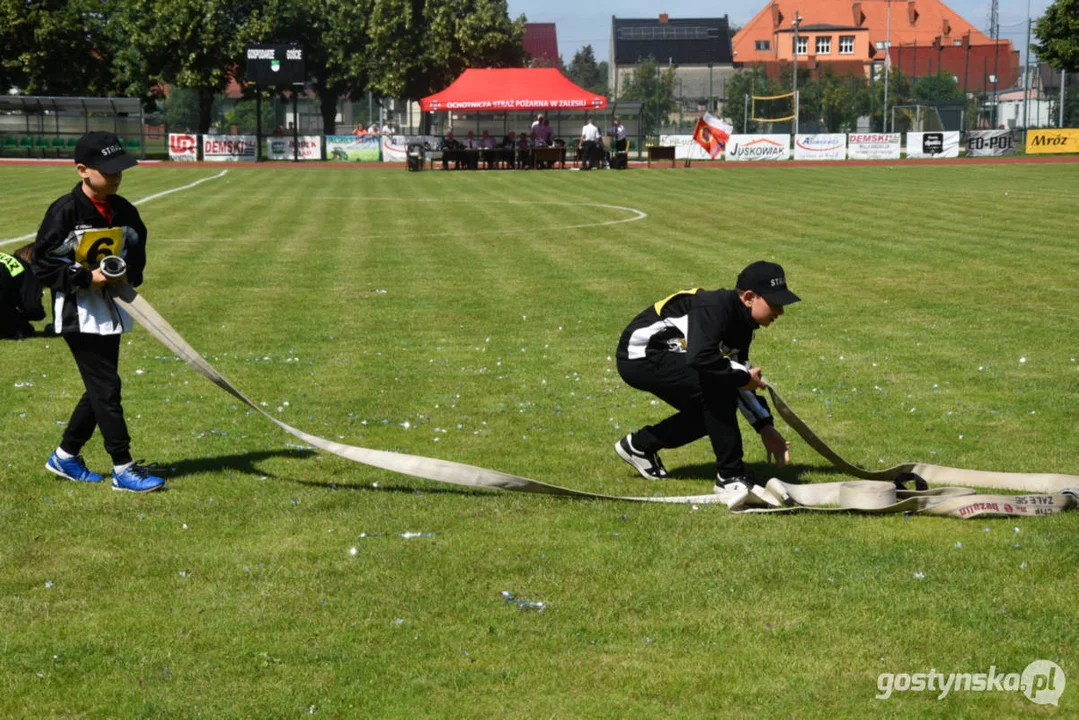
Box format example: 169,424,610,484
0,0,120,95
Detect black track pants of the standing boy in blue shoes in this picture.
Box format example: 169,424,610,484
60,332,132,465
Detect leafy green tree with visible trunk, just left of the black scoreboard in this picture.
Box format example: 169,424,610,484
114,0,270,133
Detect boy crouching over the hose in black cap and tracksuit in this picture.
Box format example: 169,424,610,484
615,261,800,492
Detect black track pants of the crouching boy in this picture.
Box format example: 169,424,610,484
618,353,746,476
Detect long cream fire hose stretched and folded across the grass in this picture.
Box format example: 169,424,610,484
112,283,1079,518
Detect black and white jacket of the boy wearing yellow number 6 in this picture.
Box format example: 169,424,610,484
33,185,146,335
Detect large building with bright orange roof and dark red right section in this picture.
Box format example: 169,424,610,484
734,0,1019,92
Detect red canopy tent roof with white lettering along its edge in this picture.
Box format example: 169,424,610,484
420,68,606,112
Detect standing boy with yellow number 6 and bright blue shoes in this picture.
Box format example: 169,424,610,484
32,132,164,492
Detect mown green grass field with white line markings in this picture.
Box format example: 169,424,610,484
0,165,1079,718
